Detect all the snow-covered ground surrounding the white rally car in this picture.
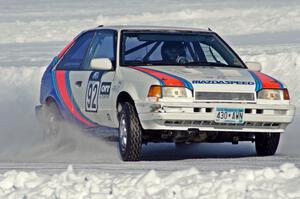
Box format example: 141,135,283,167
0,0,300,198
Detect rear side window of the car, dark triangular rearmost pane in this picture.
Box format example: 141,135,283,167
57,32,94,70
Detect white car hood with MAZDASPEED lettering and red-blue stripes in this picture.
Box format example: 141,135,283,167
127,66,284,92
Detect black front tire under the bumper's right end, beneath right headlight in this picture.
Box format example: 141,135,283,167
255,133,280,156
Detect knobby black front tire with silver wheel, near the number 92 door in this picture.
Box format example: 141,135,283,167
119,102,142,161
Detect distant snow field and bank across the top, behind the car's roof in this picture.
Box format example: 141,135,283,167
0,0,300,43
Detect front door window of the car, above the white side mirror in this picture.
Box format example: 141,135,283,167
83,30,116,69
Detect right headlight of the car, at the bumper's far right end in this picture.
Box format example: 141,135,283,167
257,89,290,100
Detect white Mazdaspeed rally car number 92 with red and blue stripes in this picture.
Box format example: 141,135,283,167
36,26,295,161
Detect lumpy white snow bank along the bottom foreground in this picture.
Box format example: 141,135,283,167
0,163,300,199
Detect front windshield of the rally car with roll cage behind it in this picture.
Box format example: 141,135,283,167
121,31,244,68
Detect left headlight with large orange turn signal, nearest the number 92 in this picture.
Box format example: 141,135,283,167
148,85,193,99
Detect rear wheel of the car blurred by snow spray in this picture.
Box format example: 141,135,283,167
42,102,62,140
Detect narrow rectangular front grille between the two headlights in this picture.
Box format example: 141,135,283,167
195,92,255,102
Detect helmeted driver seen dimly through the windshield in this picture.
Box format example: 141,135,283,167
161,41,187,64
